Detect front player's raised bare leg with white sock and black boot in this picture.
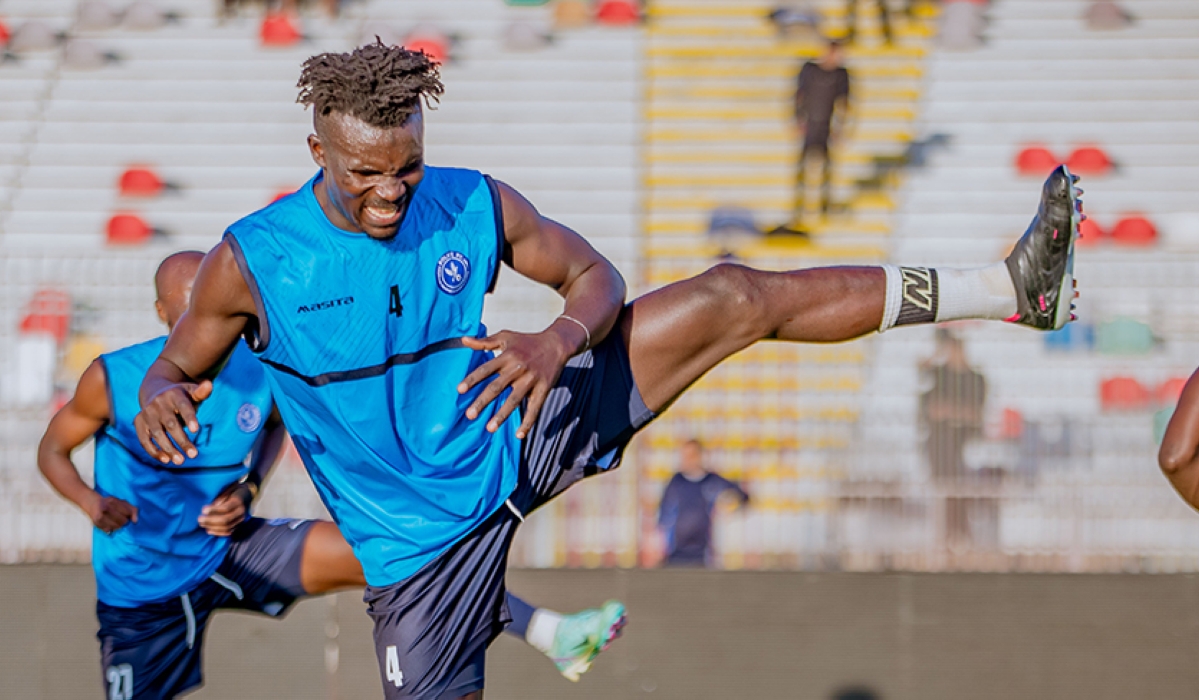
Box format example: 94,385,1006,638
621,165,1083,412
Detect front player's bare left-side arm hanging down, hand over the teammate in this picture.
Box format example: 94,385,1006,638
134,241,255,464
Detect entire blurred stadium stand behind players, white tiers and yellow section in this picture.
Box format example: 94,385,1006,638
7,0,1199,571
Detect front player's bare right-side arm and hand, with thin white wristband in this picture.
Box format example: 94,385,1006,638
458,182,625,438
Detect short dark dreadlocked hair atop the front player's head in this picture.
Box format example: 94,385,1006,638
296,37,445,128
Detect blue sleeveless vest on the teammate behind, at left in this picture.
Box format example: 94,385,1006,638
91,337,272,608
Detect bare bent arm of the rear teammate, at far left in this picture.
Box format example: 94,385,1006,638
37,360,138,532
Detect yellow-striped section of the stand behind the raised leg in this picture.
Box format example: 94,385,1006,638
640,0,932,568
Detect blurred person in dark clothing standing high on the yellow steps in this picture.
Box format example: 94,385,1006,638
793,41,849,230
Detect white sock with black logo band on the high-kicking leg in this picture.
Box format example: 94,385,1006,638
879,263,1016,331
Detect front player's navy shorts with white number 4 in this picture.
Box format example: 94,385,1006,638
364,330,653,700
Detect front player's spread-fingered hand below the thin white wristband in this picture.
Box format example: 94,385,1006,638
458,328,577,440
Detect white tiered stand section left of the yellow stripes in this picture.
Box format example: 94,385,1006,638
0,0,640,565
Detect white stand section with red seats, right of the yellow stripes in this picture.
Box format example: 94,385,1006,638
858,0,1199,571
